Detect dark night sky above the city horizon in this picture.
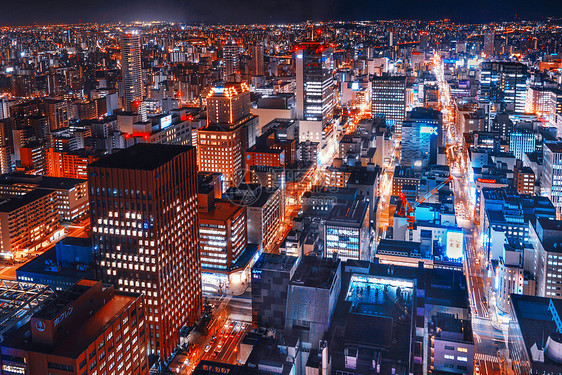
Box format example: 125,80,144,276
0,0,562,25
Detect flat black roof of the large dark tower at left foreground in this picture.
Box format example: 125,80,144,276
90,143,193,171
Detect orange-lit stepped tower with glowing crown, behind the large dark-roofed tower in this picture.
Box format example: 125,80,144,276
197,82,258,189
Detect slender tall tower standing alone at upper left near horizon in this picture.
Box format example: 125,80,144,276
121,31,143,111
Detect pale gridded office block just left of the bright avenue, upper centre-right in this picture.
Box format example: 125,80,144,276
371,76,406,135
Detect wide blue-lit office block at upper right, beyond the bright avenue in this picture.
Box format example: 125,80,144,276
480,62,528,113
